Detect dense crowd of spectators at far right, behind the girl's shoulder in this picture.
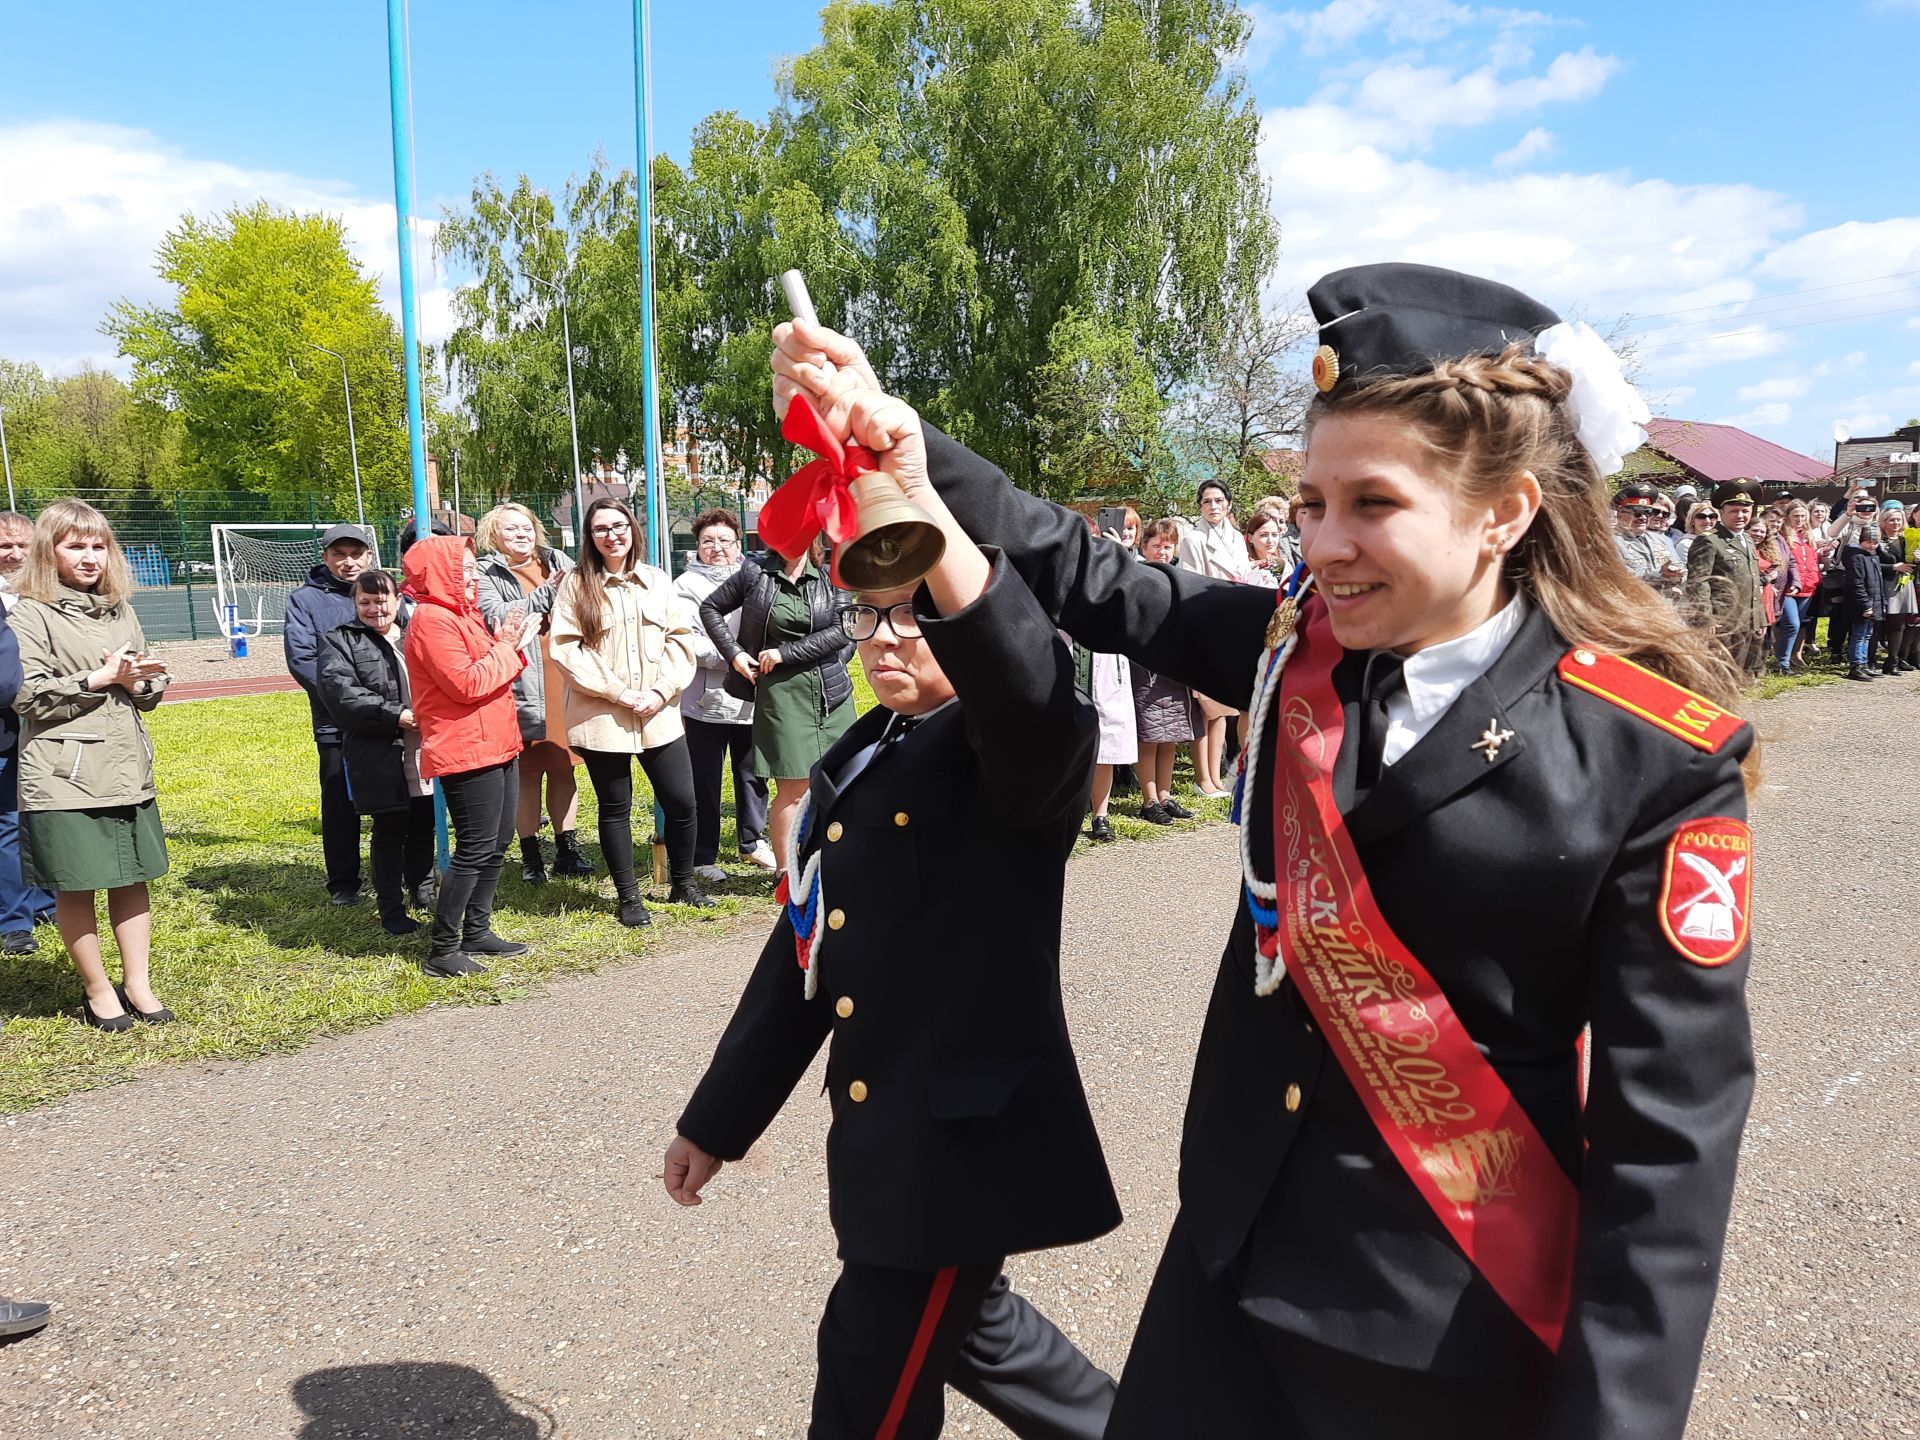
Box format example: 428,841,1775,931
1613,480,1920,680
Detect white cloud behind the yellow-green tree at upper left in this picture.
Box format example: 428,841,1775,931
0,121,451,371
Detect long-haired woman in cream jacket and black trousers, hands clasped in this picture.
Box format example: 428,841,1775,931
547,499,712,925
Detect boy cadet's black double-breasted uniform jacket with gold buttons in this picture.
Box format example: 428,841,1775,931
680,557,1119,1269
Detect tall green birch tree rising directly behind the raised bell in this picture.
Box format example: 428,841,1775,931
774,0,1275,493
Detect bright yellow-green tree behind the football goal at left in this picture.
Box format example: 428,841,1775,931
102,202,411,513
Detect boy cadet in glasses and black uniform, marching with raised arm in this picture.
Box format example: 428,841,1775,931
664,382,1119,1440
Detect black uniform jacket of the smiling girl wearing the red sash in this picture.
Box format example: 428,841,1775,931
929,432,1753,1440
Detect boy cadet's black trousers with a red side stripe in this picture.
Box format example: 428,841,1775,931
806,1261,1114,1440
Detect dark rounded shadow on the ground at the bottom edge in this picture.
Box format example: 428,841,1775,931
294,1361,559,1440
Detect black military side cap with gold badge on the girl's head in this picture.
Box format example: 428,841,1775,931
1308,265,1559,396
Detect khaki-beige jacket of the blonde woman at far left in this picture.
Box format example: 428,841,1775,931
10,586,167,810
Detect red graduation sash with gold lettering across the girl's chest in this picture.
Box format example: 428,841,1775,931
1258,603,1578,1352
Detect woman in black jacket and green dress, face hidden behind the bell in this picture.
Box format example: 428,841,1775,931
701,540,852,866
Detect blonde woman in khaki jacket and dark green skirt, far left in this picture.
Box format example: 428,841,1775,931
10,499,173,1031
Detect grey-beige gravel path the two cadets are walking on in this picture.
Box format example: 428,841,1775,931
0,682,1920,1440
